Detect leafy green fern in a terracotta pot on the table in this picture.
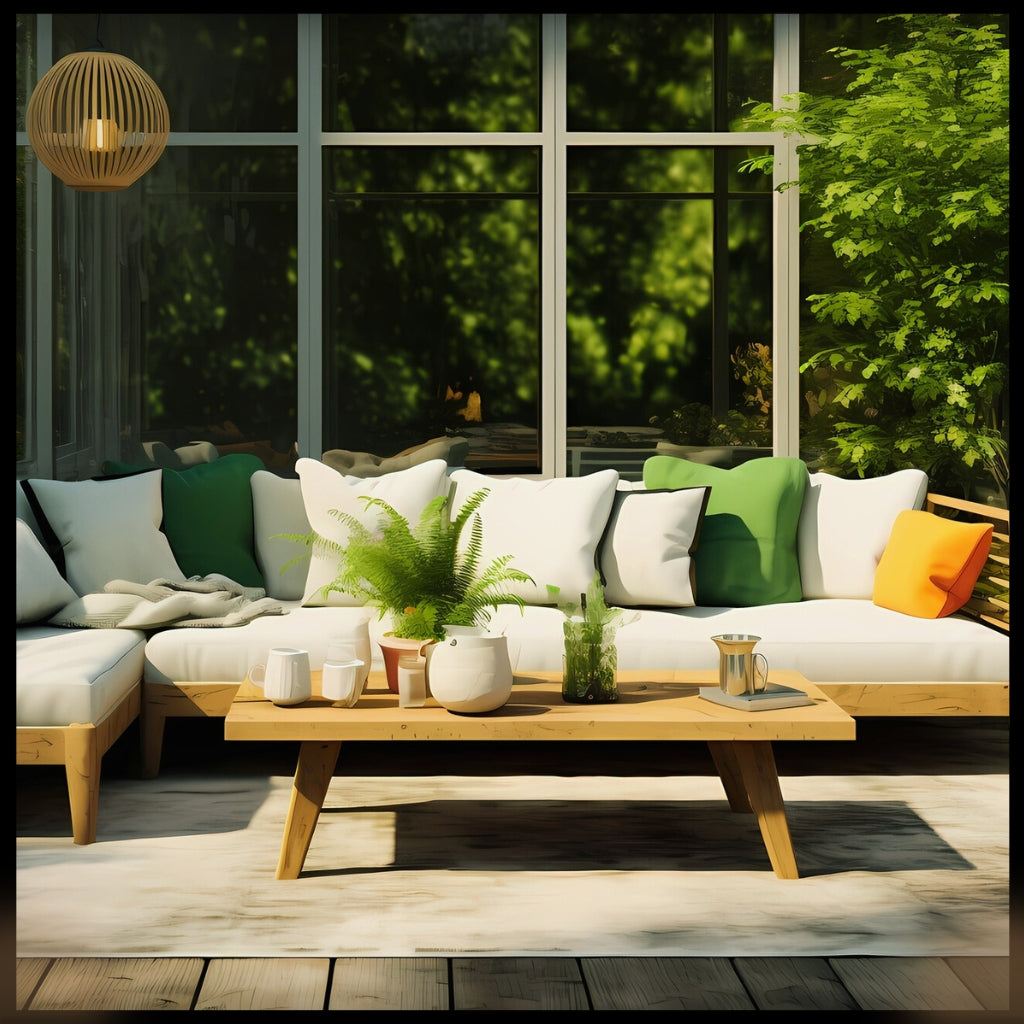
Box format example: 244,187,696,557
325,483,534,691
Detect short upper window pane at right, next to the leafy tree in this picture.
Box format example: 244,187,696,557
566,13,772,131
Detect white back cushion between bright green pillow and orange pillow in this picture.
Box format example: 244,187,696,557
797,469,928,600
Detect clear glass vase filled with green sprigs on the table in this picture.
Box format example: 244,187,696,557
559,573,625,703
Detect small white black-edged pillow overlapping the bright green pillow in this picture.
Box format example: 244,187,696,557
600,483,711,608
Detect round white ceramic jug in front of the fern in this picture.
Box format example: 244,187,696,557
426,634,512,714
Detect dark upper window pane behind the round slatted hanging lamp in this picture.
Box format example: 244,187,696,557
53,14,298,132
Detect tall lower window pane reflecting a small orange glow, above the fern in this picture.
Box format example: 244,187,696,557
324,146,541,472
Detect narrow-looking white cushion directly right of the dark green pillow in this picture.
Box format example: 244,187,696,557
249,469,309,601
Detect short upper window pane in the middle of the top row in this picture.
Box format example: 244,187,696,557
324,14,541,132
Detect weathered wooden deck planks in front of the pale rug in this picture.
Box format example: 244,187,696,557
16,956,1019,1007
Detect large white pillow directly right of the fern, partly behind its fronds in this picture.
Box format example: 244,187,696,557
452,469,618,604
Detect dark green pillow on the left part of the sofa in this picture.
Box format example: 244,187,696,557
103,454,266,588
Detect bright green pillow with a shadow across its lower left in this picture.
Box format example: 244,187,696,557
643,455,808,607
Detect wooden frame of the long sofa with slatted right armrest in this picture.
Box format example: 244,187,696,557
140,494,1010,778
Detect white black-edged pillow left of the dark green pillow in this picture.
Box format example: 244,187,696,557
24,469,184,594
